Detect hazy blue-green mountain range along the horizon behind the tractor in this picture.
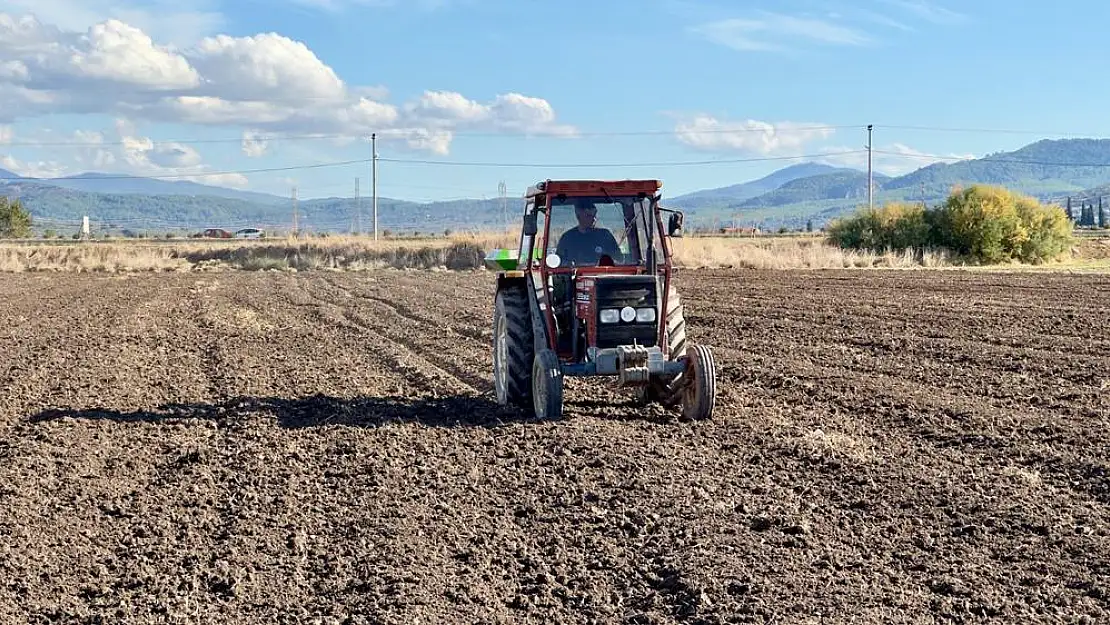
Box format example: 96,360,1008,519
0,139,1110,233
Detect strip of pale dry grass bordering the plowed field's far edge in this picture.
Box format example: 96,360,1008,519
0,227,1107,273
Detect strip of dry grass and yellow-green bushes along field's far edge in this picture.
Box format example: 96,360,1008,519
0,187,1110,273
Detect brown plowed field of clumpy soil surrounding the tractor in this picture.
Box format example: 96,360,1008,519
0,271,1110,624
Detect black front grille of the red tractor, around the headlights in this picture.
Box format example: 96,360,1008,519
595,275,659,349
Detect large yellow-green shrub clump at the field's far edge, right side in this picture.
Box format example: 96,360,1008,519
828,185,1072,263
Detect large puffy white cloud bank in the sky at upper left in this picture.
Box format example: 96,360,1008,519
0,11,575,155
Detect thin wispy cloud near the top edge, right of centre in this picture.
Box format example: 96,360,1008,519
692,11,871,51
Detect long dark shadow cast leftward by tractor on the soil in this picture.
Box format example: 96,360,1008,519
28,395,555,430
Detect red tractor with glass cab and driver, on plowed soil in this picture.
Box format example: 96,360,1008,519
485,180,716,421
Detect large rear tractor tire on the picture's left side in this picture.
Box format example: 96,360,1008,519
493,286,535,410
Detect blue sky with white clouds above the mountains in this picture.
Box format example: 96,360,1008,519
0,0,1110,201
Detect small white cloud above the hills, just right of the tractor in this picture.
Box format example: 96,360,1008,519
675,114,835,155
